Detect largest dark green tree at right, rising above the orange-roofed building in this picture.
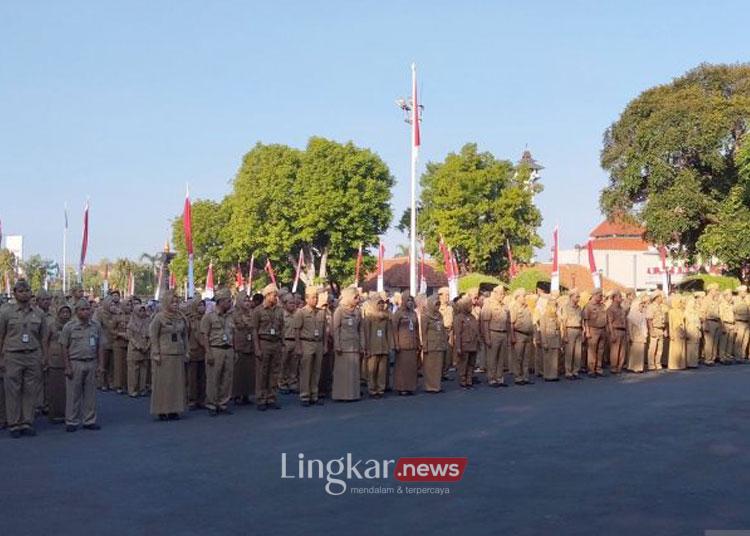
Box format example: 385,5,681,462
600,64,750,256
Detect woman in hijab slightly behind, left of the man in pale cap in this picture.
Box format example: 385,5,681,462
232,290,255,405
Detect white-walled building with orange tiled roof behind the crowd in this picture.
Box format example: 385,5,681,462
560,220,697,290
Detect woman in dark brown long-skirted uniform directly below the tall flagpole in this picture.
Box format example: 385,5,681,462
392,292,421,396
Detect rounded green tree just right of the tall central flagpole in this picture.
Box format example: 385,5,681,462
408,143,543,273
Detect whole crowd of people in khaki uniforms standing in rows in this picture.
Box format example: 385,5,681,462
0,279,750,438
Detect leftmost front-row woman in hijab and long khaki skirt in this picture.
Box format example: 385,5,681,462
150,291,188,421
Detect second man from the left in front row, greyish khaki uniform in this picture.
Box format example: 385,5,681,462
60,299,104,432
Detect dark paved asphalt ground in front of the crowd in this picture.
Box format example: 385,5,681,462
0,365,750,536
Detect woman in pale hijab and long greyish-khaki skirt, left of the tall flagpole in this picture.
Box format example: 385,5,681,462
331,287,364,400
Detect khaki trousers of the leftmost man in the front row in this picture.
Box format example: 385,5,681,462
5,350,42,430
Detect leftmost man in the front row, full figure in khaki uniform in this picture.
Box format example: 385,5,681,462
0,279,48,438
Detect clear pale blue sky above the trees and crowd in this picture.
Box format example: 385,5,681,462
0,0,750,261
